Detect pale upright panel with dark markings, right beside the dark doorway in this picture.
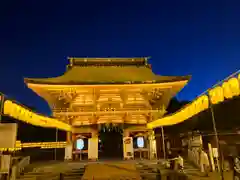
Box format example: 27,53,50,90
123,137,134,159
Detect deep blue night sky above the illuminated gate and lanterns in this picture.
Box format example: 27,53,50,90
0,0,240,113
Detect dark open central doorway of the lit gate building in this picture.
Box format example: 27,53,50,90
99,126,123,159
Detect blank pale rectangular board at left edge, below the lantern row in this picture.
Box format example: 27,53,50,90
0,123,17,149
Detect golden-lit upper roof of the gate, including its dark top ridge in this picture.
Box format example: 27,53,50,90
24,58,190,85
